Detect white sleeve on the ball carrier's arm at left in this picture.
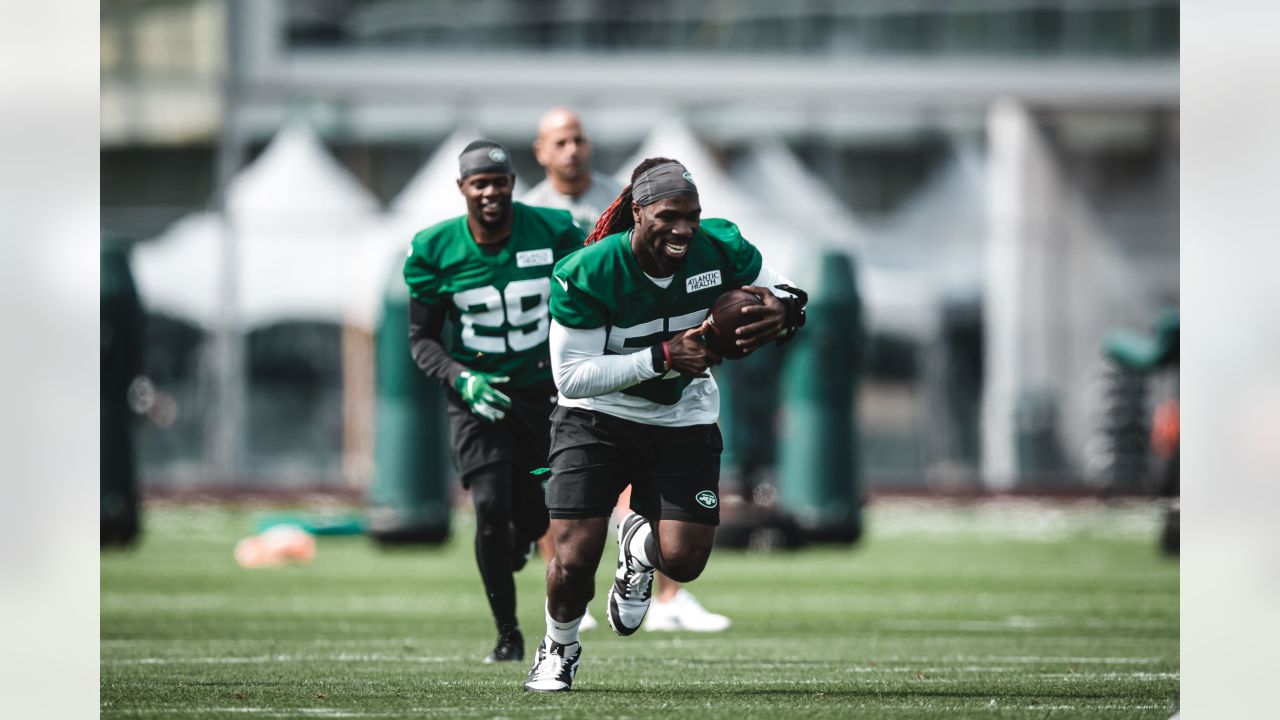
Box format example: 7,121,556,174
550,320,658,400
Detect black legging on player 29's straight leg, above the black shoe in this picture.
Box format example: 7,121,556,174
468,464,516,633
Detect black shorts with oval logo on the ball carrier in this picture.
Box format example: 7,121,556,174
547,406,724,525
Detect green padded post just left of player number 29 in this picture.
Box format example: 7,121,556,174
369,272,452,543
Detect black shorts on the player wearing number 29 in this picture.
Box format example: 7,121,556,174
445,380,556,487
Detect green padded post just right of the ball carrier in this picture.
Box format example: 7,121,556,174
778,251,865,542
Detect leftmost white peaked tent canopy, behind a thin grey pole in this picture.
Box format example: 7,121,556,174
133,124,381,328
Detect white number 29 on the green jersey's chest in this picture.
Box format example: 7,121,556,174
453,278,552,354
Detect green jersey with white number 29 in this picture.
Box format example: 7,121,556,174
404,202,585,387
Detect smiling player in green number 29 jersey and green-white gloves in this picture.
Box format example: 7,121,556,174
404,140,584,662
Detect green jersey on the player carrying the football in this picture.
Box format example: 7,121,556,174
550,218,762,414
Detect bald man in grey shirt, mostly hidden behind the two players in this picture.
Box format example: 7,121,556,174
520,108,730,633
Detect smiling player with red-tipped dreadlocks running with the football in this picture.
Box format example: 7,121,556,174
525,158,804,692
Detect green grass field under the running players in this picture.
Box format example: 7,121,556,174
101,500,1179,720
